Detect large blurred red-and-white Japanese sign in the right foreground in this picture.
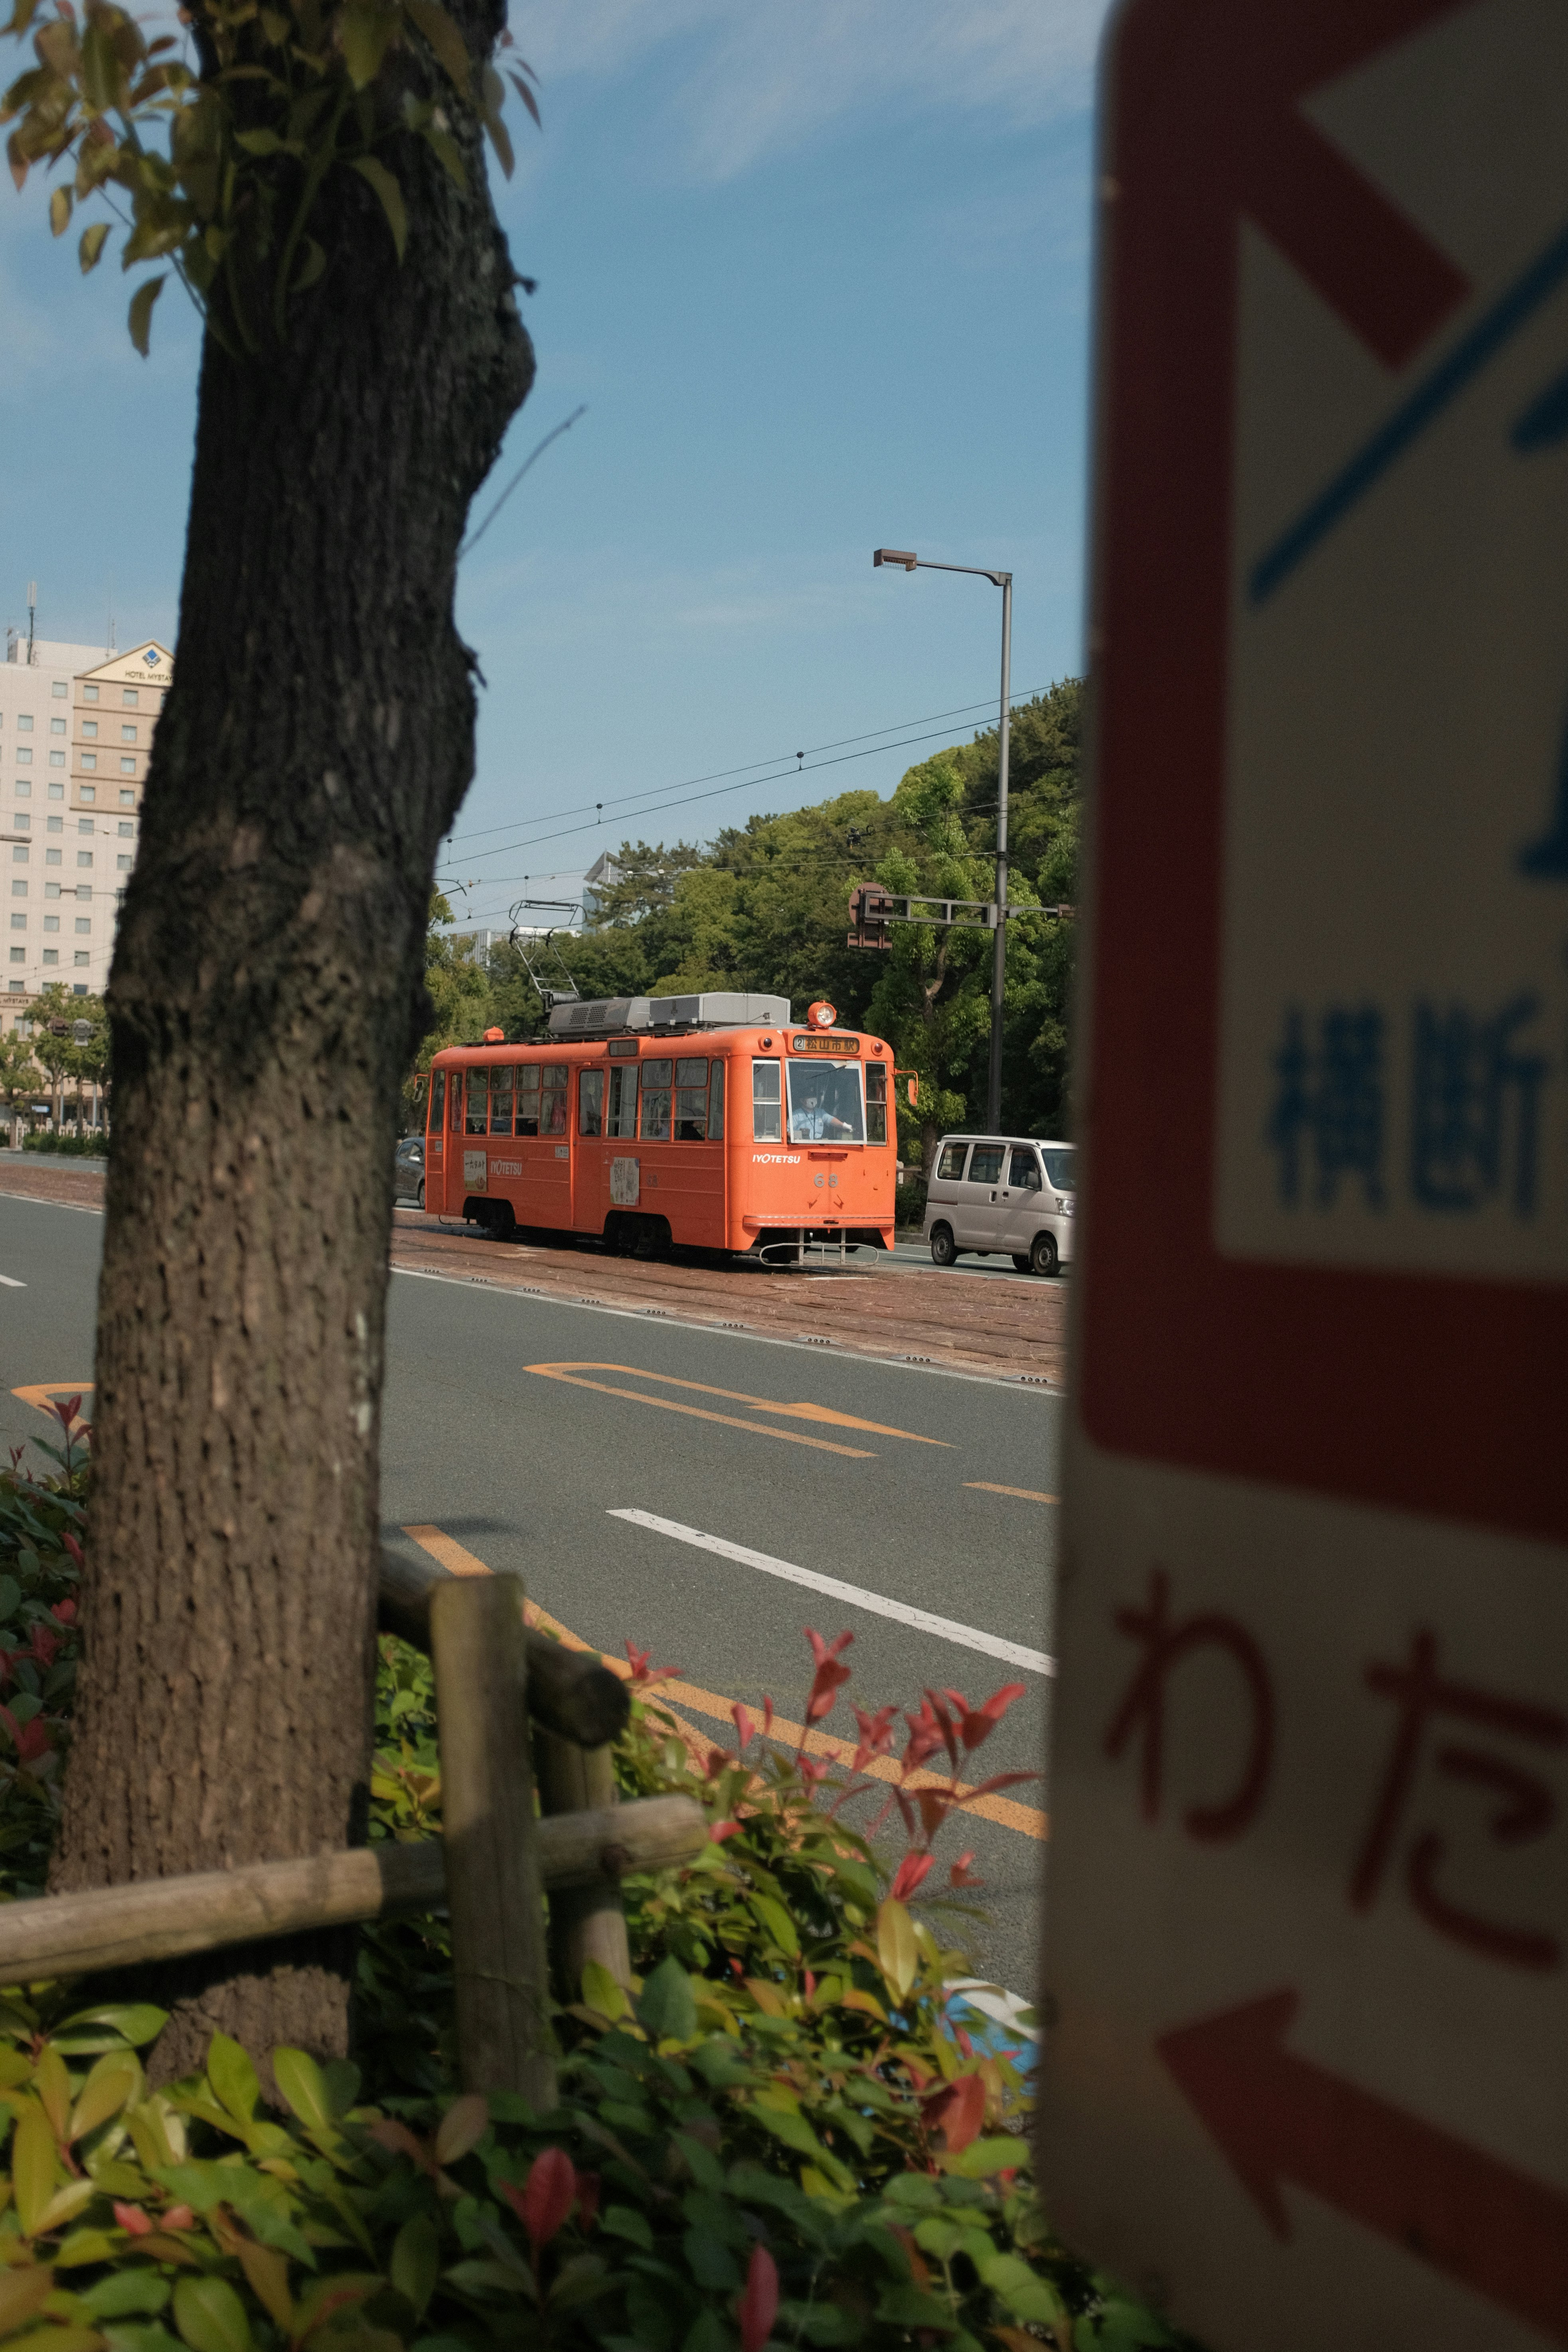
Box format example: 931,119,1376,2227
1041,0,1568,2352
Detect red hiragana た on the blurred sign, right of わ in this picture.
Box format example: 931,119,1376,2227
1349,1627,1568,1969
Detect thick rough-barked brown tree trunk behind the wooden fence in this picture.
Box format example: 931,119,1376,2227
49,14,533,2079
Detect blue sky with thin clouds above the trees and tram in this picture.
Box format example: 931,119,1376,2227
0,0,1098,922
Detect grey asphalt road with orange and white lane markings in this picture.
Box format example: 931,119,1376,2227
0,1197,1060,1995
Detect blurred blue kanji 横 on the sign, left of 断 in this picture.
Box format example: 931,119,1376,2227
1267,1004,1382,1209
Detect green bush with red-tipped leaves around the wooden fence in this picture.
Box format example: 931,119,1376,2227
0,1400,1175,2352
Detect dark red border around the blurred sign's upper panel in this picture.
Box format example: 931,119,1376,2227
1079,0,1568,1540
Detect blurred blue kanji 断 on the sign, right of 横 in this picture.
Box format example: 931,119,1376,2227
1410,990,1549,1216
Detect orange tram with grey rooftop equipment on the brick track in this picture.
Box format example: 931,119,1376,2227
425,993,914,1263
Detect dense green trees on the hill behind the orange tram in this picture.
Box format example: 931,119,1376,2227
421,677,1081,1159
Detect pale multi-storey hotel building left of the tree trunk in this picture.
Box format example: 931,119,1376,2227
0,633,174,1028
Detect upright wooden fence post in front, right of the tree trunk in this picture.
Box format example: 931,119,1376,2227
430,1576,555,2112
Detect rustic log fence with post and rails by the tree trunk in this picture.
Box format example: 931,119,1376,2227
0,1552,708,2107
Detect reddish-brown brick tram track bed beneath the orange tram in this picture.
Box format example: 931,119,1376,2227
0,1155,1067,1388
